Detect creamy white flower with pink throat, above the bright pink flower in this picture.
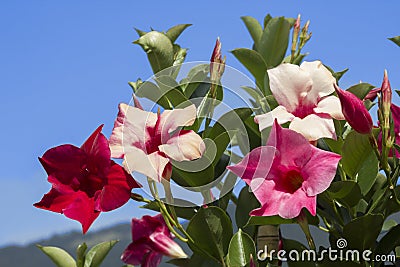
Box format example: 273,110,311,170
255,61,344,141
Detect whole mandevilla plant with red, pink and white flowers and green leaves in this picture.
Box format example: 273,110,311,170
34,10,400,267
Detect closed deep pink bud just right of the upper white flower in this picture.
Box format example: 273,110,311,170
334,84,372,134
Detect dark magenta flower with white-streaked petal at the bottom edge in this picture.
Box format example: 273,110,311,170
121,214,187,267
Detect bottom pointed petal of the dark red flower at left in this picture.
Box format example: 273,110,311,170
63,192,100,234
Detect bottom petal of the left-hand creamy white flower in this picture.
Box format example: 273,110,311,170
124,147,169,182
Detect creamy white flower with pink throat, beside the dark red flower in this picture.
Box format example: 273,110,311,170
110,103,205,182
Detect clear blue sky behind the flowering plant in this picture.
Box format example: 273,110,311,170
0,0,400,246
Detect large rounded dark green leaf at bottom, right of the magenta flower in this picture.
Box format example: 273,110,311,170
187,206,233,262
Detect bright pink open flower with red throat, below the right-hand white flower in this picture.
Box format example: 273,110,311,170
228,120,341,218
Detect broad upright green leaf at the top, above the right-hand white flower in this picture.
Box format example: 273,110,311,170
258,17,290,68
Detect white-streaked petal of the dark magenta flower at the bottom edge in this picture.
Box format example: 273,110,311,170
149,232,187,259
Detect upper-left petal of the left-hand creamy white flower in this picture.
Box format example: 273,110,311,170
110,103,157,158
